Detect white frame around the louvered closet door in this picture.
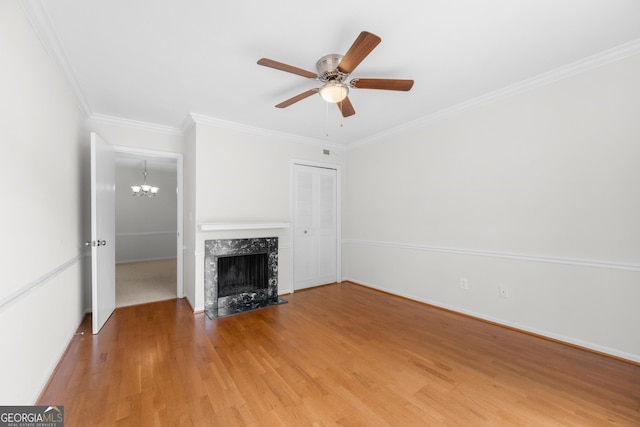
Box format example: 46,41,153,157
289,159,342,293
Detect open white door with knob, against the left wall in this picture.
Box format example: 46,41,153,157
90,132,116,334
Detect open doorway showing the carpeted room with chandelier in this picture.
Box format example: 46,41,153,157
115,147,183,307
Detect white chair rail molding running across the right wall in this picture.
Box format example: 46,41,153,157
342,239,640,271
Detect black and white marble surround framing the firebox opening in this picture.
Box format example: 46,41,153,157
204,237,279,317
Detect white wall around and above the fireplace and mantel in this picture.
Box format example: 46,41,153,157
185,122,344,310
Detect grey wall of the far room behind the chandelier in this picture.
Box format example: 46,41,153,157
115,165,178,263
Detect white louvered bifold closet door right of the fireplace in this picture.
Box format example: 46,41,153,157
293,165,337,290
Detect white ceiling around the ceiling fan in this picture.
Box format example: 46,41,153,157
22,0,640,144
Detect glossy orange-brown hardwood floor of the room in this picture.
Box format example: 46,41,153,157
39,283,640,426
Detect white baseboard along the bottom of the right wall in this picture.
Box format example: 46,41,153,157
343,278,640,366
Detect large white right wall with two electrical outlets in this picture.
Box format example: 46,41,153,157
343,55,640,361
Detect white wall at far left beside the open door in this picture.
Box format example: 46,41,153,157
0,0,89,405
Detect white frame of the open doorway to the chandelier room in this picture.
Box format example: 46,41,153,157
113,145,184,298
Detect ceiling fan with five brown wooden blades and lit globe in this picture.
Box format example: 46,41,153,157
258,31,413,117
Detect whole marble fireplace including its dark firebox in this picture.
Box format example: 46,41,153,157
204,237,286,318
